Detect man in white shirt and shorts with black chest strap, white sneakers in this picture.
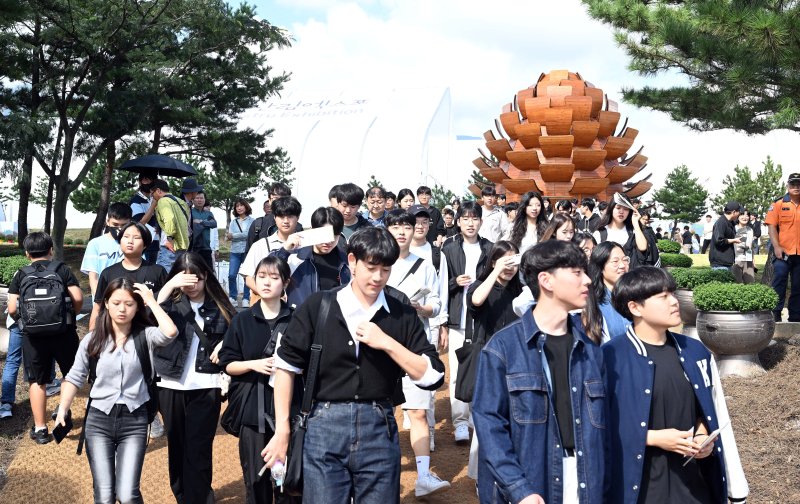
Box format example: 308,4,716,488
384,207,450,497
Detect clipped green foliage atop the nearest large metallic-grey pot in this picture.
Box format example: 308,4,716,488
694,282,778,312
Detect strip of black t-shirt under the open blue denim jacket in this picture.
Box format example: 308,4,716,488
544,332,575,449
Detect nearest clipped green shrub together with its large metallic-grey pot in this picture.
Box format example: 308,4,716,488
694,282,778,377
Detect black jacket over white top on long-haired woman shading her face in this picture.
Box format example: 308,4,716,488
153,296,228,379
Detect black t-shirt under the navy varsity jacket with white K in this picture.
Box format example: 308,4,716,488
638,339,712,504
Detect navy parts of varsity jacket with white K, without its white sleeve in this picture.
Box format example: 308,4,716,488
602,327,728,504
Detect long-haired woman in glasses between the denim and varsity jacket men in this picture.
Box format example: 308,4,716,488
584,241,630,342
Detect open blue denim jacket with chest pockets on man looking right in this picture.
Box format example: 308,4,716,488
472,311,606,504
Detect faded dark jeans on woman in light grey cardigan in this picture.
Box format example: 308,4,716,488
86,404,147,504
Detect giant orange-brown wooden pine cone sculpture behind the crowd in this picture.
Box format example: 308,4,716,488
470,70,652,201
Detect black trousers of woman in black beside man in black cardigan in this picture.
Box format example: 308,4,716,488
239,425,302,504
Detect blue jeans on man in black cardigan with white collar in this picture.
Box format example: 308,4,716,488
303,400,400,504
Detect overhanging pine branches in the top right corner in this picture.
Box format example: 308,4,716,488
582,0,800,133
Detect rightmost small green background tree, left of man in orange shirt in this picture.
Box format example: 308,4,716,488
711,156,786,218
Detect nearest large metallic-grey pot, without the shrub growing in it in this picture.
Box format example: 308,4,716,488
697,310,775,377
